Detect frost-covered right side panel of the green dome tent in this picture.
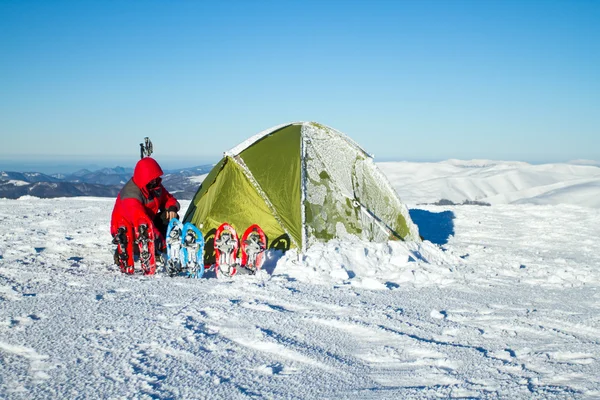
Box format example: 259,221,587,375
302,123,410,245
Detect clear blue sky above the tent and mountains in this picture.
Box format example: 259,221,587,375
0,0,600,170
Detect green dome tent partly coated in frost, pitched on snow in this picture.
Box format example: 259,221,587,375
184,122,419,262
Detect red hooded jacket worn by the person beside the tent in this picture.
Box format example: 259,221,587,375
110,157,179,238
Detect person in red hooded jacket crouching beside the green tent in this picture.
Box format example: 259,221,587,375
110,157,180,273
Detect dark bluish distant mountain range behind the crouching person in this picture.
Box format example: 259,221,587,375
0,164,213,200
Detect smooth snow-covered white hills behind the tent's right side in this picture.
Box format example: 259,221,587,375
378,160,600,208
